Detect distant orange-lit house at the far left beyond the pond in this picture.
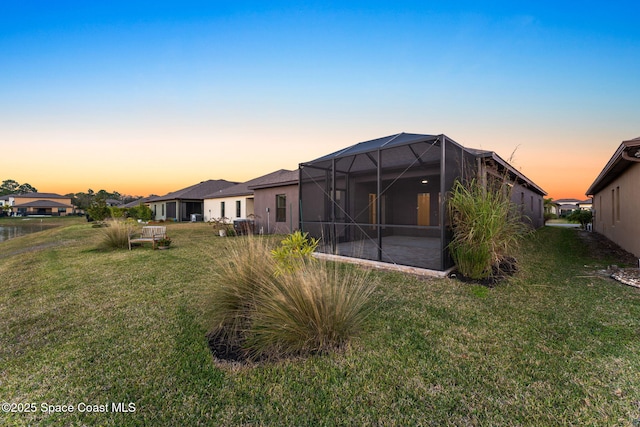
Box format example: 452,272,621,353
2,193,75,216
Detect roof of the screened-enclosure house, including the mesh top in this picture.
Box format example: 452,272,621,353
301,132,547,195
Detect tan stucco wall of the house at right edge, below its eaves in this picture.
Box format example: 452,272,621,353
593,163,640,257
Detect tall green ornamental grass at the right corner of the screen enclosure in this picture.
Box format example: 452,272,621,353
449,179,529,280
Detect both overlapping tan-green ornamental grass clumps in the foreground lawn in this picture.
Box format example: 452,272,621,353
208,236,374,360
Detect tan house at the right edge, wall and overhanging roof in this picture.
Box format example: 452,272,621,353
586,137,640,257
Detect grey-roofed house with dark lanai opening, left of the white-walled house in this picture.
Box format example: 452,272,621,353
147,179,237,221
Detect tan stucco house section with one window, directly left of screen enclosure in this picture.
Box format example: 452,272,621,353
249,169,300,234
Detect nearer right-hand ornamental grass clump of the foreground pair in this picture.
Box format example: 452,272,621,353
247,261,374,358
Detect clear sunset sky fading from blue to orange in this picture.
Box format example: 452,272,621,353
0,0,640,199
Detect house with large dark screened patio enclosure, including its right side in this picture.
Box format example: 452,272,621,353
300,133,546,271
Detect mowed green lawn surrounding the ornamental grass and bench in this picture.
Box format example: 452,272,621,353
0,219,640,426
